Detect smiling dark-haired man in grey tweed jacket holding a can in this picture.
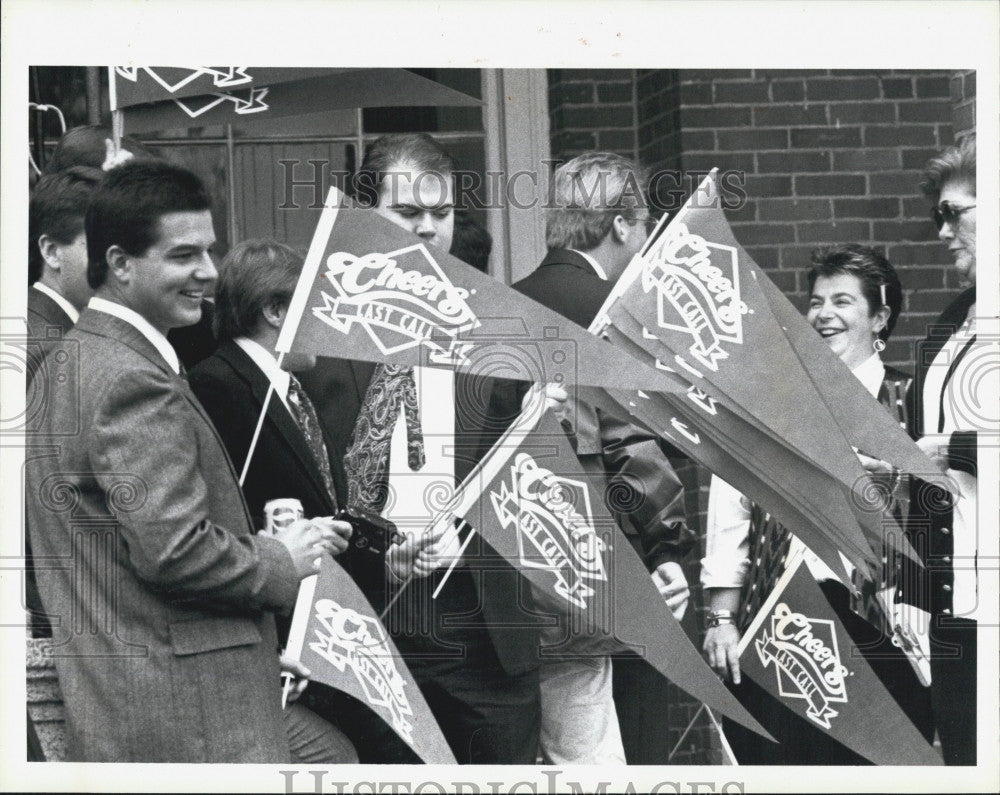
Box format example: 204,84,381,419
26,162,334,763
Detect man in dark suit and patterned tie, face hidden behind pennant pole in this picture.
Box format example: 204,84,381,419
188,240,419,763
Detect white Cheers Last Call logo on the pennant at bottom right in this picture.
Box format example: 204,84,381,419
754,602,851,729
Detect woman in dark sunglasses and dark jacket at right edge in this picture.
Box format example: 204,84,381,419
899,134,976,765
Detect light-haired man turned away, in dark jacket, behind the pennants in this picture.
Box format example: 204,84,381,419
484,152,694,764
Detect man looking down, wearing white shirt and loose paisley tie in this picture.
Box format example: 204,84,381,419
303,135,540,764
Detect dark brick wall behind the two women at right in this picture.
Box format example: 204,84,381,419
550,69,975,762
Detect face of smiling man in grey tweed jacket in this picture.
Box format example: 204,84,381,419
122,210,218,334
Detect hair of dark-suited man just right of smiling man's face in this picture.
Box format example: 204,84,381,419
212,238,303,342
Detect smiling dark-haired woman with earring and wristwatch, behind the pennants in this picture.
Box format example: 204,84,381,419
701,245,933,764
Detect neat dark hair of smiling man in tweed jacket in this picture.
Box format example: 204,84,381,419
85,160,212,290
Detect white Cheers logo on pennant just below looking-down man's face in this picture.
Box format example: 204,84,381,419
312,244,479,365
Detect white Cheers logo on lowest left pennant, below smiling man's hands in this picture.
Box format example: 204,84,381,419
309,599,413,745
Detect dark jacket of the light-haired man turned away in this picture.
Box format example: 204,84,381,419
484,249,696,570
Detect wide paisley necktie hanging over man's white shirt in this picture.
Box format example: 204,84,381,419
344,364,426,513
